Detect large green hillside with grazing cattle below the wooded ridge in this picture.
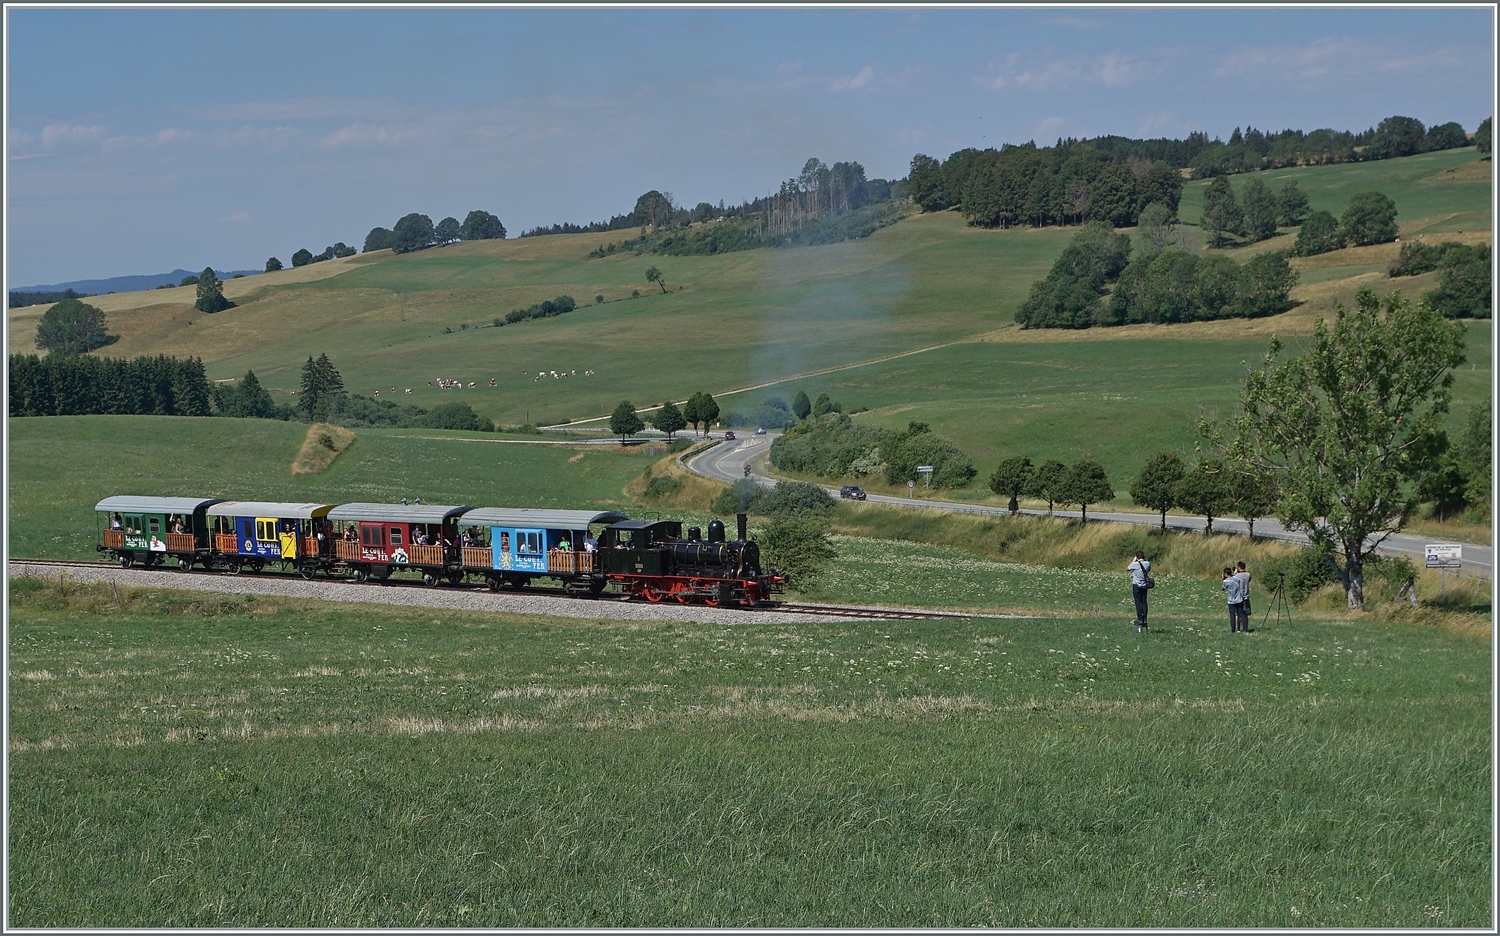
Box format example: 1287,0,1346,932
11,149,1491,498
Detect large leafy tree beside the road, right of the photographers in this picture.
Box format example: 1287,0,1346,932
1229,288,1464,609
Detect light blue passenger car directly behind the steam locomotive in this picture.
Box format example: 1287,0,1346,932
459,507,627,591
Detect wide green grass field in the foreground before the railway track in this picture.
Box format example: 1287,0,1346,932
8,570,1493,929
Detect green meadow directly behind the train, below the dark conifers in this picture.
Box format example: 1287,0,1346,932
9,416,662,558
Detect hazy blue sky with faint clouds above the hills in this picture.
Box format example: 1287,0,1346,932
6,8,1494,285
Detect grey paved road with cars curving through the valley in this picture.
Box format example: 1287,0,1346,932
684,435,1494,579
